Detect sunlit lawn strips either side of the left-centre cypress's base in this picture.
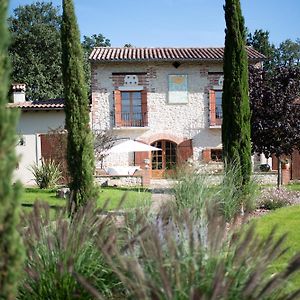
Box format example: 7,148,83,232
21,187,151,210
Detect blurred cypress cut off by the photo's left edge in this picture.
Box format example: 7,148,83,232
0,0,23,299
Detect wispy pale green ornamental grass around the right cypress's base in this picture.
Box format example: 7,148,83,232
174,165,258,222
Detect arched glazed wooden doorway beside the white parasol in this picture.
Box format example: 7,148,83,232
151,140,177,178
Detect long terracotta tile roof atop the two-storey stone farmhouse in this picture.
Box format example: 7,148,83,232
90,47,265,62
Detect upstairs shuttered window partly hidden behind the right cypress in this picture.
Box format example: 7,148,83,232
209,90,223,126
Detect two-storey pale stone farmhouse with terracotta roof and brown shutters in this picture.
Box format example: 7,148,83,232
90,47,264,178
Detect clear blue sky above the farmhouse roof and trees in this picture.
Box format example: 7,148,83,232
10,0,300,47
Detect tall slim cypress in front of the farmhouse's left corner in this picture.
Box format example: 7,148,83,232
61,0,96,211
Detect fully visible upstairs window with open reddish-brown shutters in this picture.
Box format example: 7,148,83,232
114,90,147,127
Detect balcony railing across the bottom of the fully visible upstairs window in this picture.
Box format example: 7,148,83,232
111,112,148,127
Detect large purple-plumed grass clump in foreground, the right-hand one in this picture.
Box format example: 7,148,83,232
80,205,300,300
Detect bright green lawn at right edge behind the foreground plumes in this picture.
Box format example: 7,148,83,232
254,205,300,290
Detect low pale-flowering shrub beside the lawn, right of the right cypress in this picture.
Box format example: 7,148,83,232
257,188,299,210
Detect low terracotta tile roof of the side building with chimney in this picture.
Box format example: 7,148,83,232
8,99,65,111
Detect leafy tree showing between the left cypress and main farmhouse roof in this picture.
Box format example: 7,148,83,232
81,34,111,91
